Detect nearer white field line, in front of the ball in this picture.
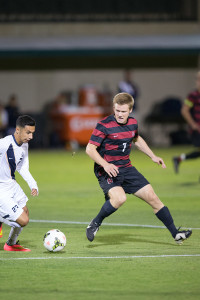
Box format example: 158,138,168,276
0,254,200,261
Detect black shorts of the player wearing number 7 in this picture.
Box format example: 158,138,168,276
95,167,149,200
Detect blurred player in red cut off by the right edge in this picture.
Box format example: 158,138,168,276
173,71,200,173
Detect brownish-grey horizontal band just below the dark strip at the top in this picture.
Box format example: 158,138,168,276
0,21,200,37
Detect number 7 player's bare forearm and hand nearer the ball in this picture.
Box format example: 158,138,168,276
86,143,119,177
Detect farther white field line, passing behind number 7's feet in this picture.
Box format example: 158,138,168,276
30,220,200,230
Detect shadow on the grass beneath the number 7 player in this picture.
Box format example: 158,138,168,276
87,234,177,248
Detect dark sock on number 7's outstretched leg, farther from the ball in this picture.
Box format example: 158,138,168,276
156,206,178,238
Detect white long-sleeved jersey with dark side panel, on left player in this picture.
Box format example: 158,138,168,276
0,135,38,190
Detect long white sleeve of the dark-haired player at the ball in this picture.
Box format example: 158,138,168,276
17,146,38,191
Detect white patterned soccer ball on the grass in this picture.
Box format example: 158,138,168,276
43,229,66,252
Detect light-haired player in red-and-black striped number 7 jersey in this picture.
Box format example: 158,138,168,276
86,93,192,244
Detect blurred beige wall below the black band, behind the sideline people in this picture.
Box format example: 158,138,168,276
0,68,196,119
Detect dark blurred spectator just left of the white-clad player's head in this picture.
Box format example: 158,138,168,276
5,94,19,135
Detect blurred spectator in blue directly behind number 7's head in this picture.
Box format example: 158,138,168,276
118,70,139,111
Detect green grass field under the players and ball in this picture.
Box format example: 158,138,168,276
0,147,200,300
